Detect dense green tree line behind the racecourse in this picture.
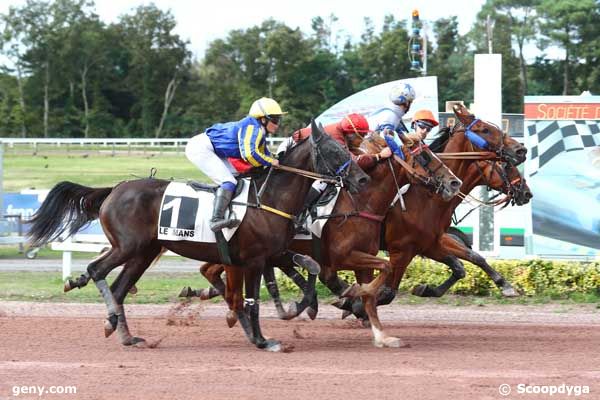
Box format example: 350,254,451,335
0,0,600,137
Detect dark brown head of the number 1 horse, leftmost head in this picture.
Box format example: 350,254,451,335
296,120,371,193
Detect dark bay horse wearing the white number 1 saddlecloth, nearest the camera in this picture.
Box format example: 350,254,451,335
28,121,370,351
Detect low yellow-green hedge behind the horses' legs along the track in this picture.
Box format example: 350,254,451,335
277,258,600,297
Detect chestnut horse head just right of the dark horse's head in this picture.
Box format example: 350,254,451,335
361,133,462,201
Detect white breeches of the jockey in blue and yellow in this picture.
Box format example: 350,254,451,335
185,133,237,185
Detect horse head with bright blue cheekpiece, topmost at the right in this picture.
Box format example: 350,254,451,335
452,104,527,165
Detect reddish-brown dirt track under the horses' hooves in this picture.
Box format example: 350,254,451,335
0,302,600,400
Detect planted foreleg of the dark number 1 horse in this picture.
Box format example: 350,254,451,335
244,267,283,352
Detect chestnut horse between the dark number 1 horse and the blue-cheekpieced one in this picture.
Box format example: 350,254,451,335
188,130,461,347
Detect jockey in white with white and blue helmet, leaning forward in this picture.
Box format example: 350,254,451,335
368,83,416,133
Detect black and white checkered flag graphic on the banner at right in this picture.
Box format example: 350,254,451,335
525,120,600,176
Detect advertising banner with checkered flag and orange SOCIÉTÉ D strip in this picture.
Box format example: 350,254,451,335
525,96,600,257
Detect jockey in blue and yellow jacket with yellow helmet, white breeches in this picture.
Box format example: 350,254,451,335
185,97,286,232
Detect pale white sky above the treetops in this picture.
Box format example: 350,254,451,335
0,0,492,58
